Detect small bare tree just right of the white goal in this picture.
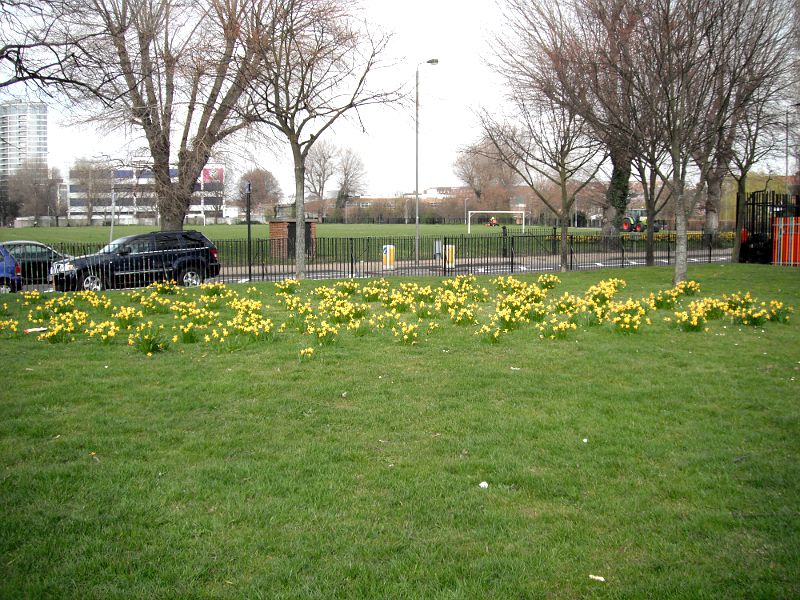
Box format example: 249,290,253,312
482,96,605,271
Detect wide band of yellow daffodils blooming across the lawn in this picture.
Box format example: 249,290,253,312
0,275,792,359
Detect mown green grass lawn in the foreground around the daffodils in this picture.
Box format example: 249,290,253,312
0,265,800,599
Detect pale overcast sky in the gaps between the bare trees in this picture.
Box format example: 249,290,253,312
49,0,503,202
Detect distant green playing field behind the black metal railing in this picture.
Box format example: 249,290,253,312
0,223,576,244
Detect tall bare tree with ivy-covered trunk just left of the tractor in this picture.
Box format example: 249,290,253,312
494,0,641,233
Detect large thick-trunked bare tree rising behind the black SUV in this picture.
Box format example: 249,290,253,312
56,0,273,229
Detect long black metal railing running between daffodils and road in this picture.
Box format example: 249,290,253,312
4,232,733,288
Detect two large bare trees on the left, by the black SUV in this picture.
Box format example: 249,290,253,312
0,0,401,276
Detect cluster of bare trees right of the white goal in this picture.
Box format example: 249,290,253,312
457,0,797,282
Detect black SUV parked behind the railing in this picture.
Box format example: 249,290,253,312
50,231,220,291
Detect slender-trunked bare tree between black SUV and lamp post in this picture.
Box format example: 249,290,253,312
253,0,399,278
